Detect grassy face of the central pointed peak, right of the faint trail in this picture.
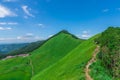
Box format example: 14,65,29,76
31,31,83,74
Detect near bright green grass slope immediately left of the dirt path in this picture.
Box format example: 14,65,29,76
32,35,99,80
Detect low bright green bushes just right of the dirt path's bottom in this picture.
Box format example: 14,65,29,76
90,59,113,80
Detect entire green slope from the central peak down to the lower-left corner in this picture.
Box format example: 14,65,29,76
0,31,83,80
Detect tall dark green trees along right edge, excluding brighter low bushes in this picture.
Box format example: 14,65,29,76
95,27,120,80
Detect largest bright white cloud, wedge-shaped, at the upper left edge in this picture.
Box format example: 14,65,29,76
0,5,17,18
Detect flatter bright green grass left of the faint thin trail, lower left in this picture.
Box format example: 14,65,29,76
0,57,31,80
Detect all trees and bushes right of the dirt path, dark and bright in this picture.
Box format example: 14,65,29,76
91,27,120,80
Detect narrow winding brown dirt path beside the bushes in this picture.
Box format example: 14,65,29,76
85,46,100,80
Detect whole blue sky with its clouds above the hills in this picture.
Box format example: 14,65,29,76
0,0,120,43
